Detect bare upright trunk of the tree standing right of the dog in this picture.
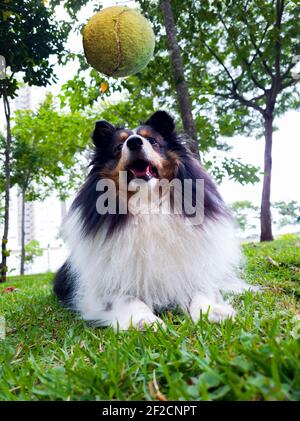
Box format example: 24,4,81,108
260,116,273,241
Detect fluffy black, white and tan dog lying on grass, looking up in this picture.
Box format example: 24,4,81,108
54,111,249,330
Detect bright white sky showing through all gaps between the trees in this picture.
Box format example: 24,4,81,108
0,0,300,204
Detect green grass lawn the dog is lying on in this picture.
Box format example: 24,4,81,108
0,235,300,400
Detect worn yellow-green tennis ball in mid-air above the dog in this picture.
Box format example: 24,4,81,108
83,6,155,77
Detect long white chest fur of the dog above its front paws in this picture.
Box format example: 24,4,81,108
64,213,243,308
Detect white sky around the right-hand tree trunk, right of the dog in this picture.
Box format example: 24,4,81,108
220,111,300,204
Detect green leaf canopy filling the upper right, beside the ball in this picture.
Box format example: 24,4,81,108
139,0,300,130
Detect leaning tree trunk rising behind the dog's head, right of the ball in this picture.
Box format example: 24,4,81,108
161,0,200,159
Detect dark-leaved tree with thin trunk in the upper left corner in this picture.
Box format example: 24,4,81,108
0,0,71,282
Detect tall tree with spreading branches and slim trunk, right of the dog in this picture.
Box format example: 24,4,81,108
184,0,300,241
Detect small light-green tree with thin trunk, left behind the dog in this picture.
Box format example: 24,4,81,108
11,95,92,275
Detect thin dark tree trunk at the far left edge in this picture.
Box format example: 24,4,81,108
0,93,11,282
